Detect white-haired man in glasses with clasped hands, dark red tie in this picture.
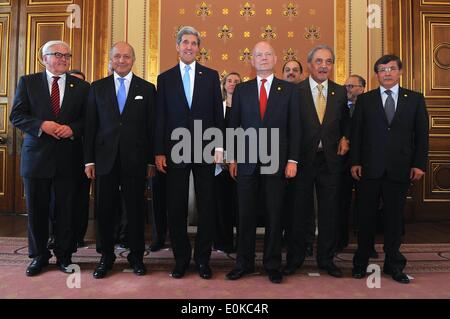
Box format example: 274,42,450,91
10,41,89,276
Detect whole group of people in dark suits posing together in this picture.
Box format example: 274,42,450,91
10,27,428,283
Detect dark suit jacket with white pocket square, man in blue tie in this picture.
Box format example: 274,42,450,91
84,74,156,176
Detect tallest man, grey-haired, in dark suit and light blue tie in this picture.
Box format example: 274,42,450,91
155,27,224,279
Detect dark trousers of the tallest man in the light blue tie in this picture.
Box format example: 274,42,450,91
167,164,215,267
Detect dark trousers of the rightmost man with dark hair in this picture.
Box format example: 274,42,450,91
353,176,409,271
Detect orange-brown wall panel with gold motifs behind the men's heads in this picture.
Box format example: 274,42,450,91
160,0,334,78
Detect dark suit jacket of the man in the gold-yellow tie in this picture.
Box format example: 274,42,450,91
298,78,350,173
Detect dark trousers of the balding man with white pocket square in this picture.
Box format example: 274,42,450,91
96,158,145,259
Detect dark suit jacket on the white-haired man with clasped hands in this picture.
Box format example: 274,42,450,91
10,71,89,178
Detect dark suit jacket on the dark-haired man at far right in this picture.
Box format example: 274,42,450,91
350,88,428,183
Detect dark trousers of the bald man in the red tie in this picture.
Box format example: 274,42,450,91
236,172,287,271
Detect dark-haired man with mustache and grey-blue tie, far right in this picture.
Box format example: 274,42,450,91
351,55,428,284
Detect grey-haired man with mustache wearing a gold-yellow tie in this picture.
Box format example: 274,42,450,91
284,45,349,277
